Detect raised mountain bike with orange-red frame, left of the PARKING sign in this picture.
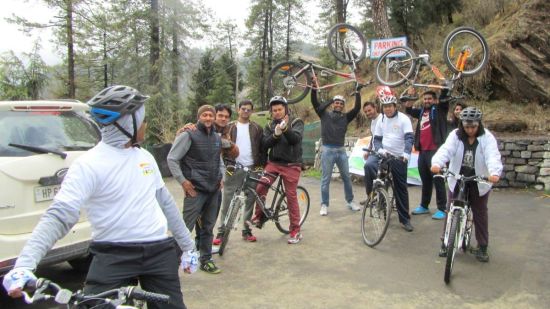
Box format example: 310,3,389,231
267,24,370,104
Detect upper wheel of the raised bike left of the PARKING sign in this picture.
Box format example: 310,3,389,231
327,24,367,64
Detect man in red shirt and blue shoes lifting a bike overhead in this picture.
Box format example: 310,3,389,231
402,88,449,220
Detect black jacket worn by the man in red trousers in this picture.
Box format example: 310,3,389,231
262,117,304,164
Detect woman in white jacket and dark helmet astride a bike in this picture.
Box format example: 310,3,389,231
431,107,502,262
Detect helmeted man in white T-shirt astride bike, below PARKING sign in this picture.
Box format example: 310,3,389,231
365,86,414,232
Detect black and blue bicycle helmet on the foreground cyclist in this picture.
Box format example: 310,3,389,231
88,85,149,125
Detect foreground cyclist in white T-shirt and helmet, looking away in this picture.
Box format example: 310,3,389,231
4,86,194,309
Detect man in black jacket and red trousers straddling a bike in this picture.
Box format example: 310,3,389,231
252,96,304,244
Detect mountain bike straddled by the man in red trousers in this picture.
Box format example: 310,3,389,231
218,163,310,256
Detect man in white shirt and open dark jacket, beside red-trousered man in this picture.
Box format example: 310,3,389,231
214,100,263,245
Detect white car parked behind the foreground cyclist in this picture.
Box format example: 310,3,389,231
0,101,101,277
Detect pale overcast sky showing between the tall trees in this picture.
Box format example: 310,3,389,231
0,0,330,65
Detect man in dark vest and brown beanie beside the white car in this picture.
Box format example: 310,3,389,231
167,105,223,274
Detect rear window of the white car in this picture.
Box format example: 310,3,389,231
0,111,101,157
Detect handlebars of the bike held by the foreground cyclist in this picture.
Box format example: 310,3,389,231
23,278,170,309
